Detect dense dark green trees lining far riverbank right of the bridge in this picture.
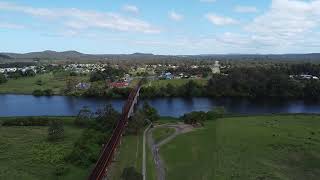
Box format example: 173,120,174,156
141,65,320,100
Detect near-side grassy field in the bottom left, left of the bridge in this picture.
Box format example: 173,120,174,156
0,117,88,180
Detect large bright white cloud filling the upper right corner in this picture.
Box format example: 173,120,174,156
245,0,320,45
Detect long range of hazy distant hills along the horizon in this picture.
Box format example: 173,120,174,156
0,50,320,63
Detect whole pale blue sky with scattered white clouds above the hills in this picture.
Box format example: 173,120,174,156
0,0,320,55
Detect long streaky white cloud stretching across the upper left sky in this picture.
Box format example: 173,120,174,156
0,2,161,33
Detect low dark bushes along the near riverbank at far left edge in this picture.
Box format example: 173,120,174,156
2,117,49,126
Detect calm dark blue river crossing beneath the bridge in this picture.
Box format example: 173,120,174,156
0,95,320,117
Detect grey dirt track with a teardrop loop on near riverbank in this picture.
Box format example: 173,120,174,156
147,123,193,180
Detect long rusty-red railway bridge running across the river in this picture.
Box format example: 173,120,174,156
88,81,142,180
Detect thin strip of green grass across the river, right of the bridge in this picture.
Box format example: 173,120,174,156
146,79,208,88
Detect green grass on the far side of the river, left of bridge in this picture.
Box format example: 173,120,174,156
0,73,88,94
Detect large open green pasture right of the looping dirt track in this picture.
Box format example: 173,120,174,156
160,115,320,180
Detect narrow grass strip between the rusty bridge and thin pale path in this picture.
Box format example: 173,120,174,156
109,135,143,180
